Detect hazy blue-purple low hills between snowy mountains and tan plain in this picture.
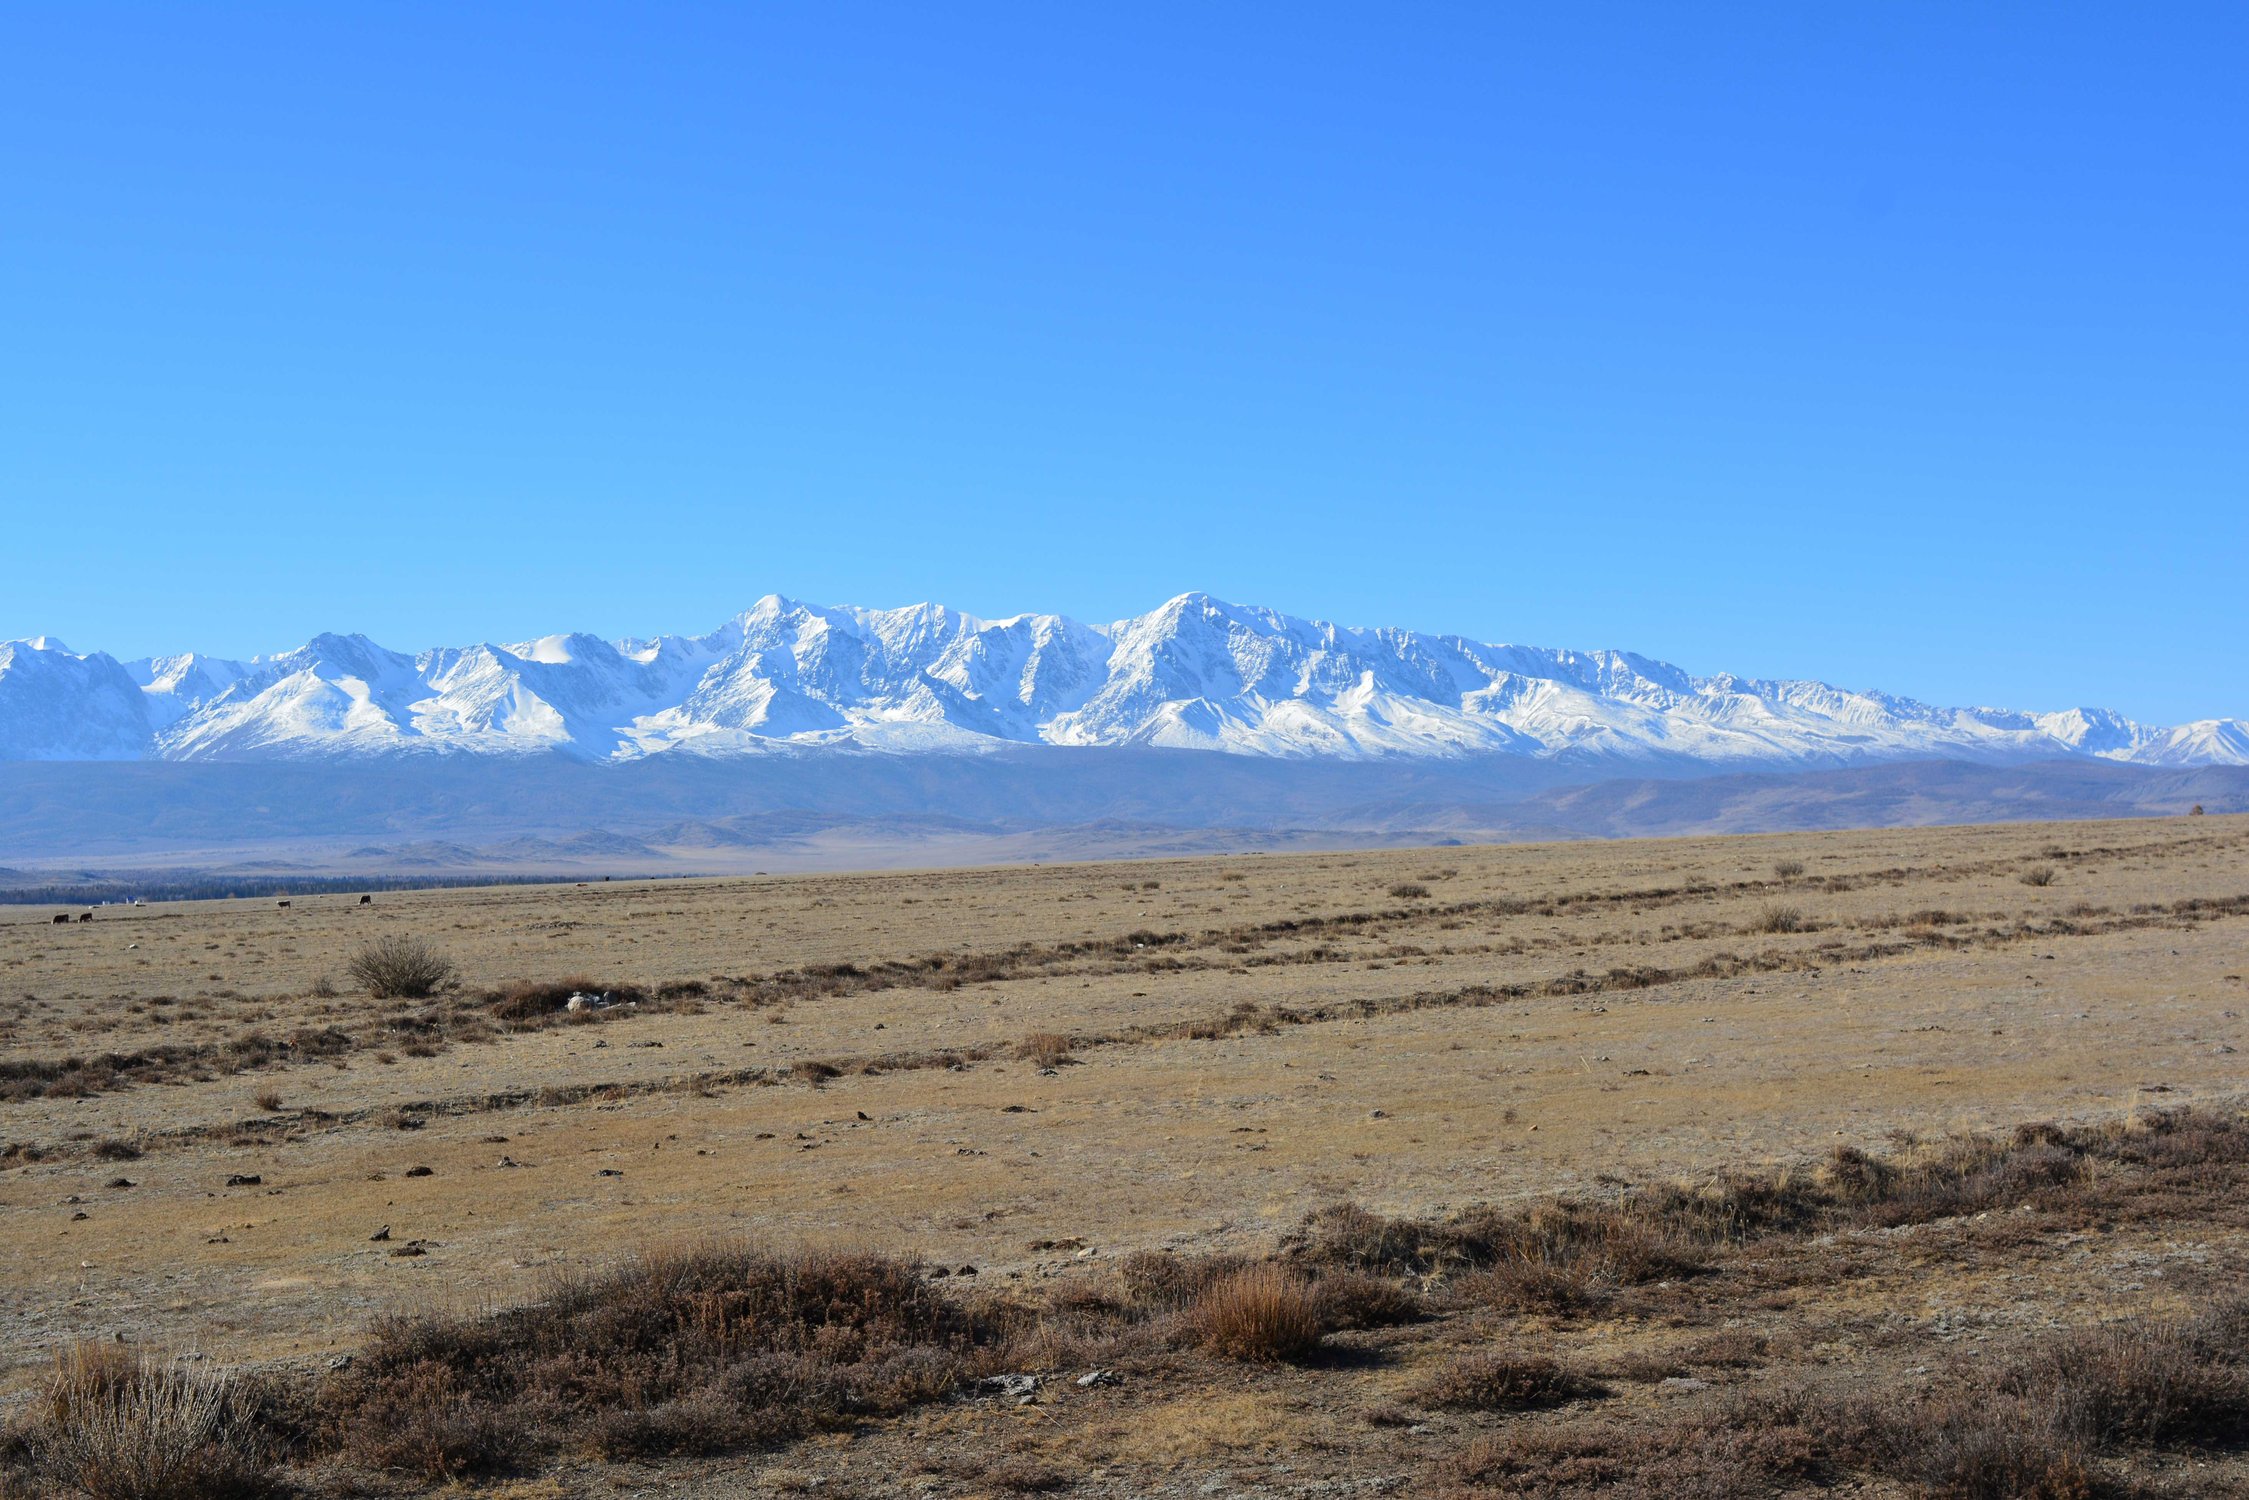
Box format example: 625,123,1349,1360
0,747,2249,884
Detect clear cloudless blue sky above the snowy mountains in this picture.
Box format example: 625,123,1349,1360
0,0,2249,722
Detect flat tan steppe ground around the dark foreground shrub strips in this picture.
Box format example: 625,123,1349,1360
0,816,2249,1496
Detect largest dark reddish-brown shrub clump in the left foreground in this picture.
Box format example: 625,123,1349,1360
322,1248,1008,1480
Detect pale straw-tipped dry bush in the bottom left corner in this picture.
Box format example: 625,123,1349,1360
25,1343,274,1500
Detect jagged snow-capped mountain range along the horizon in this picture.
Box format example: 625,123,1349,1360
0,594,2249,767
